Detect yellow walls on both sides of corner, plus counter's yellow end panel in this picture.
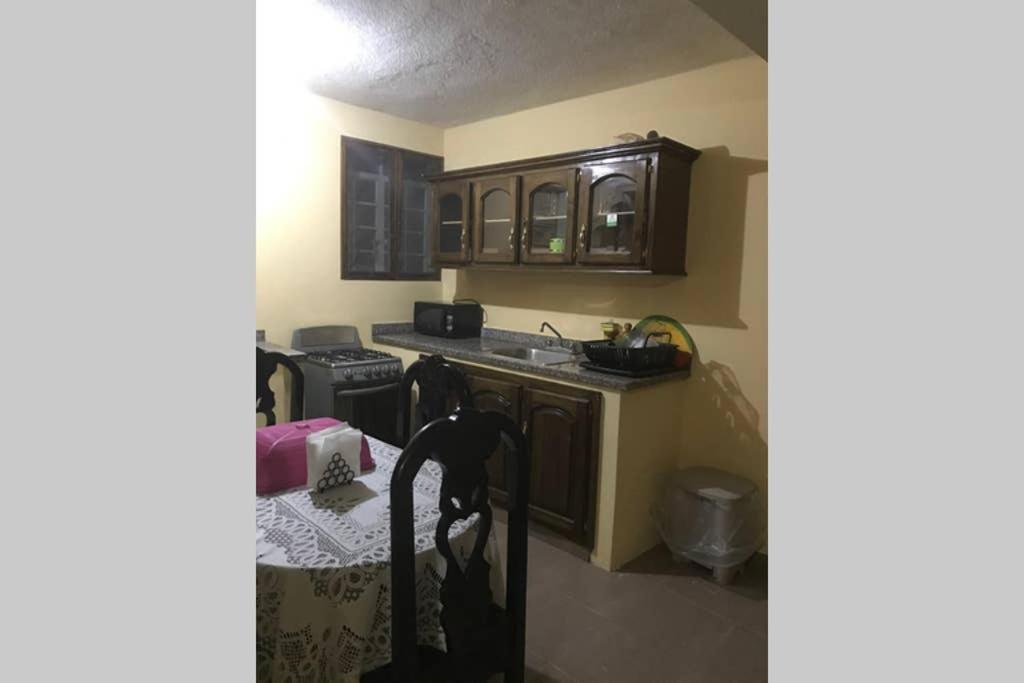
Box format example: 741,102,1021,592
256,57,768,567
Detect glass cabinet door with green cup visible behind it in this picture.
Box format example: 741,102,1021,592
519,168,577,263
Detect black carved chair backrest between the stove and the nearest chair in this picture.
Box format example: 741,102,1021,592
398,354,473,445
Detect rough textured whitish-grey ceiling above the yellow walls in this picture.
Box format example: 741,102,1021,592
299,0,752,127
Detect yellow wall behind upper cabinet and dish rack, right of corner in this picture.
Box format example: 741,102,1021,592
443,57,768,548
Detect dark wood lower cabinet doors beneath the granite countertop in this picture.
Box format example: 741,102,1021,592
454,364,601,549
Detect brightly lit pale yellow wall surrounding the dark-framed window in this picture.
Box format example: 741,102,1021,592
256,89,443,346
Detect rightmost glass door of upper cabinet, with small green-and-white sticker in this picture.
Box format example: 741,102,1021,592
577,159,648,265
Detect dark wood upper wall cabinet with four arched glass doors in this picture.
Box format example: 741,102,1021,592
432,137,700,275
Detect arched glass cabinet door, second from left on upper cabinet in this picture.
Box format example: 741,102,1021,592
473,176,519,263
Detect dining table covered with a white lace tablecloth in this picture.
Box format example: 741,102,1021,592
256,436,505,683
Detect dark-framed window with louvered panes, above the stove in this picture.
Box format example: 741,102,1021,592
341,137,444,280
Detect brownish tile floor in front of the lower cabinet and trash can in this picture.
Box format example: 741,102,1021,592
496,522,768,683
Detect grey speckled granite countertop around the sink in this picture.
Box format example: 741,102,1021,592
373,323,689,391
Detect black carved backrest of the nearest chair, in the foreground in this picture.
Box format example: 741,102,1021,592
390,408,529,683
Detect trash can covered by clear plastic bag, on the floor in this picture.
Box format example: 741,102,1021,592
651,467,765,568
